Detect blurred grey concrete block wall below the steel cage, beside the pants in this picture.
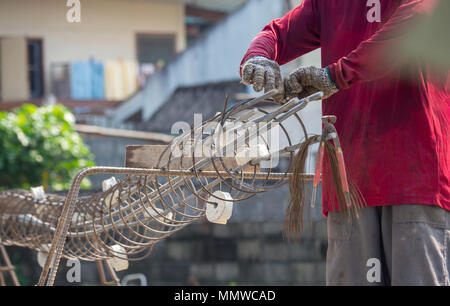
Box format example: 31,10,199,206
112,186,327,285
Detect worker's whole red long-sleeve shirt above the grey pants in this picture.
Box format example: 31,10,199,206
242,0,450,214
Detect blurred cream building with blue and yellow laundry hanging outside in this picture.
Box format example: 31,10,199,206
0,0,243,102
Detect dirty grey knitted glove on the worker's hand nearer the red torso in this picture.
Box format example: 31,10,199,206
284,66,339,99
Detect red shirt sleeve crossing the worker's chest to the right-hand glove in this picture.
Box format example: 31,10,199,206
328,0,437,89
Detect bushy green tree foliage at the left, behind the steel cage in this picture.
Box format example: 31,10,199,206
0,104,94,190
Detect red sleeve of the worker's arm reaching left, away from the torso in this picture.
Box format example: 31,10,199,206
241,0,320,73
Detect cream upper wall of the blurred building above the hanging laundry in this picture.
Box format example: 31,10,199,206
0,0,186,97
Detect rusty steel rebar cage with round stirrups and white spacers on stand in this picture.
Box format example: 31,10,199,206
0,90,364,286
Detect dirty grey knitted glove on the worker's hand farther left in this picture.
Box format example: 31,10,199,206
241,56,284,104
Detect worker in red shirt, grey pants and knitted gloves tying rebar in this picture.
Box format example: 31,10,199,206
240,0,450,285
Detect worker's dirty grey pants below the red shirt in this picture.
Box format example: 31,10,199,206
326,205,450,286
